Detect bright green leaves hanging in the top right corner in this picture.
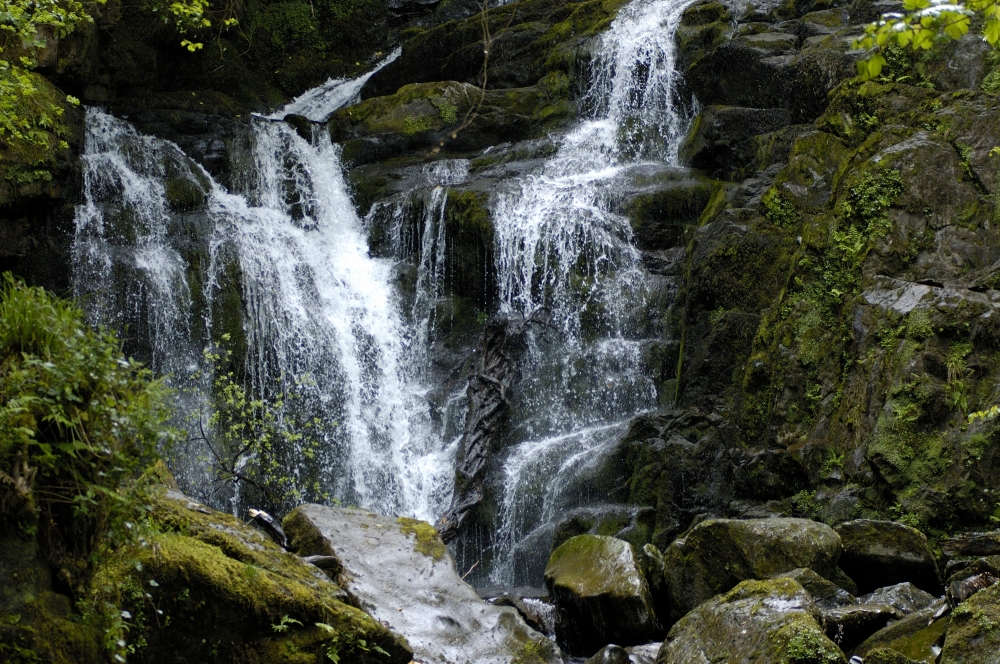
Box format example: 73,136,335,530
854,0,1000,79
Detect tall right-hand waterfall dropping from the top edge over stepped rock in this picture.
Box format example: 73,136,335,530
489,0,692,584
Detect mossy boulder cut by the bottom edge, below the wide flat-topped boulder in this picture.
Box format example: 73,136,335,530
656,578,845,664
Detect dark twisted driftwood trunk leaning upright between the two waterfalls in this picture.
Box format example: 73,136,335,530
435,311,548,542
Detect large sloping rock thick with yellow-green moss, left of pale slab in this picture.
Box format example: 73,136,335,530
95,489,412,664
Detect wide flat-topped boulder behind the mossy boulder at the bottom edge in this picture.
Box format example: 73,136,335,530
663,518,841,621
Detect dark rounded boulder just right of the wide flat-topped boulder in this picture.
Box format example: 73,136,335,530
836,519,941,594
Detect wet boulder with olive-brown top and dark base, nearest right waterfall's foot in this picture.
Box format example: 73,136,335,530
545,535,656,655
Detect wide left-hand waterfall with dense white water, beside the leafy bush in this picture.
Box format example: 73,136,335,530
74,53,454,519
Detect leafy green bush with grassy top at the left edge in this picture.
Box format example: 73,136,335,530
0,275,169,590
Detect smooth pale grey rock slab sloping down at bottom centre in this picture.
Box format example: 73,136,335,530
283,505,562,664
